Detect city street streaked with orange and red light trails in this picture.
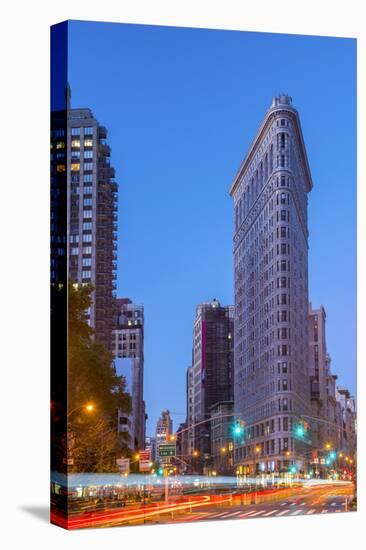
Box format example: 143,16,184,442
54,482,353,529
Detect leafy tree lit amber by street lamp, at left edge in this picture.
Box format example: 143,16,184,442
67,283,131,472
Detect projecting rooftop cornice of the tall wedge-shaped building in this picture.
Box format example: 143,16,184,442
229,100,313,196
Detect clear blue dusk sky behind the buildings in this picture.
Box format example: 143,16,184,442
68,21,356,435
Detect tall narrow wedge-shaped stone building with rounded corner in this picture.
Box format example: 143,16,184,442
230,95,313,472
